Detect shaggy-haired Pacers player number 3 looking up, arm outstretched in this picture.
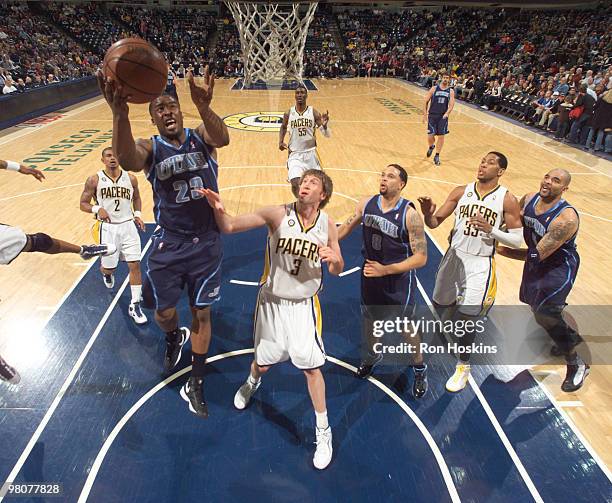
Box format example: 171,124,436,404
202,169,344,470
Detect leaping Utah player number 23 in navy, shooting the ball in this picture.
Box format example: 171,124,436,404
98,68,229,417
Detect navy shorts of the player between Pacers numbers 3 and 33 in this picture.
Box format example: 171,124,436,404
361,271,416,317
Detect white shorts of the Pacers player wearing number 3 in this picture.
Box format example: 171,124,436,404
255,290,326,370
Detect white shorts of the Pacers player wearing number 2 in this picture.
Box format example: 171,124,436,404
92,220,141,269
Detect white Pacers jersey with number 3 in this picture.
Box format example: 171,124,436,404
260,203,329,300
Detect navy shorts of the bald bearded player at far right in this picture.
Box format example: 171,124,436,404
519,254,580,311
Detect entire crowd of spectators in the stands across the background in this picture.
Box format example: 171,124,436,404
0,1,612,151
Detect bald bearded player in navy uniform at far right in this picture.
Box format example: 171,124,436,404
498,169,589,392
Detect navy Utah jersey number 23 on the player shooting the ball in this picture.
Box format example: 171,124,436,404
147,128,219,234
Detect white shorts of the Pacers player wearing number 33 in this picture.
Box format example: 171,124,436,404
433,248,497,316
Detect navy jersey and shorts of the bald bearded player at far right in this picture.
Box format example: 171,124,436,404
520,195,580,308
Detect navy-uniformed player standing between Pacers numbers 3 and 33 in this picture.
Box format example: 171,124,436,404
338,164,427,398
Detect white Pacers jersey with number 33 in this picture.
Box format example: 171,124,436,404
451,182,508,257
